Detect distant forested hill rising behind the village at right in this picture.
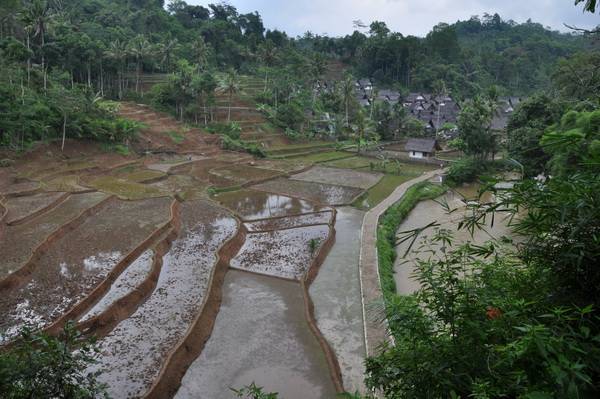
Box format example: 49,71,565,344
330,14,592,98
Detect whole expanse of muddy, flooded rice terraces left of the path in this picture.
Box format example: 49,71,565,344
0,101,432,398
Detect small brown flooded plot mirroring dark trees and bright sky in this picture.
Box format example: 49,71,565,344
213,190,323,220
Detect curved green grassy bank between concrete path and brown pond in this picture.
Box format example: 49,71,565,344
377,182,446,331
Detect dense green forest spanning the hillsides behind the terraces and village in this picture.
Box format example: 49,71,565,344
0,0,595,148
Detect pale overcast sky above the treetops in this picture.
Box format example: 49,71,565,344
187,0,600,36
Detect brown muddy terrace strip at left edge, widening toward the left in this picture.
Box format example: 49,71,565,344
0,193,108,279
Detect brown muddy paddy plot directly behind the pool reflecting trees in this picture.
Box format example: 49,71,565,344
252,178,363,205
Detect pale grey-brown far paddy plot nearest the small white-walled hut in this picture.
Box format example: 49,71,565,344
292,166,383,190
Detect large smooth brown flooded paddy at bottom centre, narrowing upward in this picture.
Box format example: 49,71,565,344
175,270,336,399
